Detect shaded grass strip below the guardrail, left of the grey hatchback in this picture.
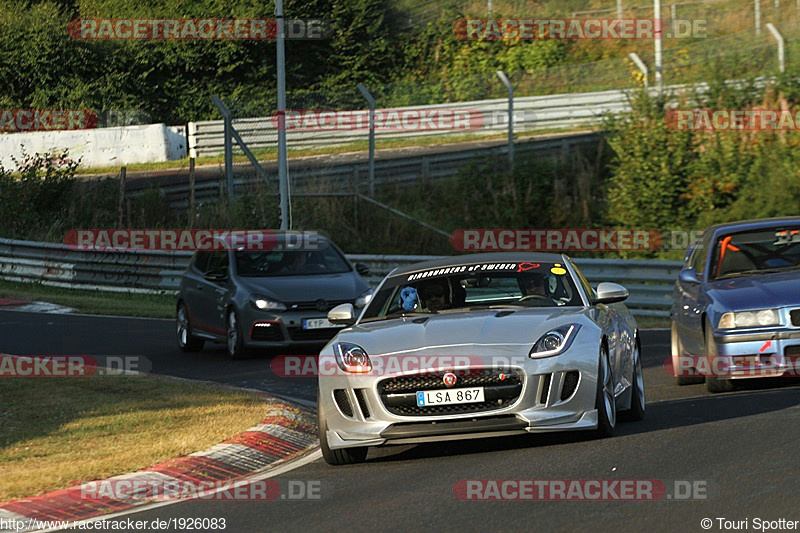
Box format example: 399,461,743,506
0,281,176,318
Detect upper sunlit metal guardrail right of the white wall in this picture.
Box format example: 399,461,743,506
188,90,630,157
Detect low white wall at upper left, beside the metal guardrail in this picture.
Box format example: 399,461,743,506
0,124,186,170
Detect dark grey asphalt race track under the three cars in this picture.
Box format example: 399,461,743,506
0,312,800,533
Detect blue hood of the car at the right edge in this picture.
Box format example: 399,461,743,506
706,270,800,311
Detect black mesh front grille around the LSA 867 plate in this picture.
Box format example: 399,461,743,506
378,369,523,416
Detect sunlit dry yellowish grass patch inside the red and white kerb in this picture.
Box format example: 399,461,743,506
0,376,266,502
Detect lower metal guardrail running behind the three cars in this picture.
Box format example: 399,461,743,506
0,239,681,317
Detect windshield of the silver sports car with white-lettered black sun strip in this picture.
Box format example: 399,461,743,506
364,262,583,321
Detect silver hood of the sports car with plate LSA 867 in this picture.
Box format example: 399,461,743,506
334,307,592,355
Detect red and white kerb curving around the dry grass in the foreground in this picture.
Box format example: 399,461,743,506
0,395,318,533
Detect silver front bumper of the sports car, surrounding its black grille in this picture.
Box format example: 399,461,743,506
319,342,598,449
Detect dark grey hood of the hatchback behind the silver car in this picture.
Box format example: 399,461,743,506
240,272,369,302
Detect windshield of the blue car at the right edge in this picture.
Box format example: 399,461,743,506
711,228,800,278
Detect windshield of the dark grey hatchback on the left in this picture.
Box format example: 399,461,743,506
235,246,350,277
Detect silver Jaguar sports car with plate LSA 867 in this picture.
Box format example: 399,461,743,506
318,253,645,464
